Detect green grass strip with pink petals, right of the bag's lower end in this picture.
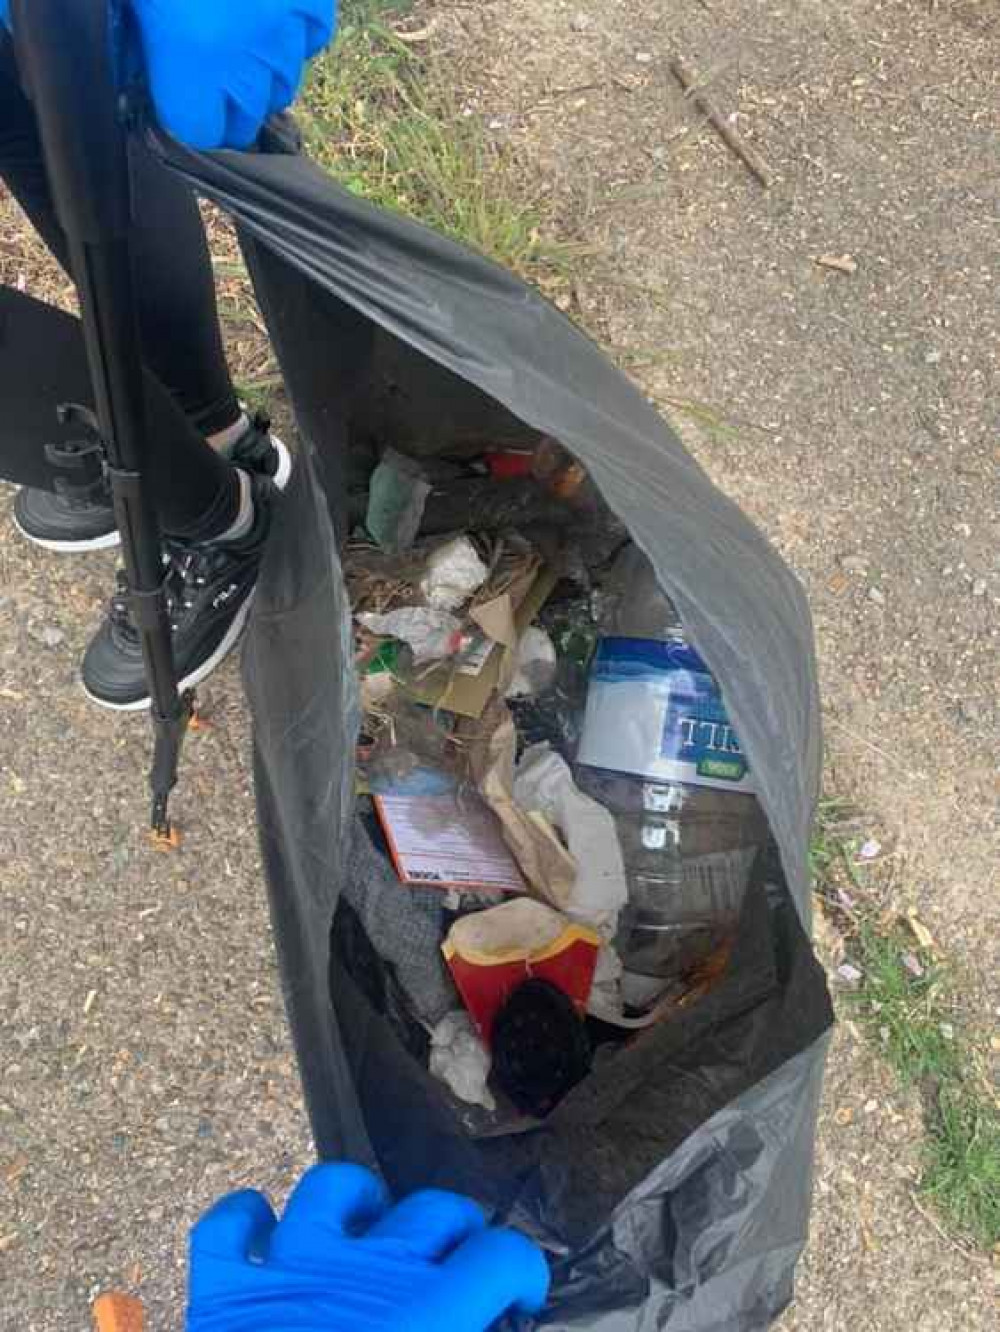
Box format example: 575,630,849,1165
812,810,1000,1251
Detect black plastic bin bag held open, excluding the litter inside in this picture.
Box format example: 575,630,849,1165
158,119,832,1332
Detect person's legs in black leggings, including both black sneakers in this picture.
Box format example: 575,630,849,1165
0,36,286,709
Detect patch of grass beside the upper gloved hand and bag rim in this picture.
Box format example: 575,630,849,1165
298,0,578,289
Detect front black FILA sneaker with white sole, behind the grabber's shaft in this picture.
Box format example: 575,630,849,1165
81,477,276,711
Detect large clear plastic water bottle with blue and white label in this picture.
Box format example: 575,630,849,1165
577,546,768,988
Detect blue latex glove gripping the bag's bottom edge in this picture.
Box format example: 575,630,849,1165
188,1164,549,1332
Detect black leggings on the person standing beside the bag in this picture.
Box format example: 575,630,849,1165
0,35,240,541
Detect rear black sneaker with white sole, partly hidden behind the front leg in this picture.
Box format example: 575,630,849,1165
13,416,292,553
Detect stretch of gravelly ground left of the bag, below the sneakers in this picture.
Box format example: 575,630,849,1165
0,524,310,1332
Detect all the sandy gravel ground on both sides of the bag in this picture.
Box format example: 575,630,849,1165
0,0,1000,1332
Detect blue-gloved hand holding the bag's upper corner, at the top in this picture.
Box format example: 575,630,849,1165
129,0,337,148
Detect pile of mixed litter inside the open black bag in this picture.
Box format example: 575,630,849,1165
344,440,767,1130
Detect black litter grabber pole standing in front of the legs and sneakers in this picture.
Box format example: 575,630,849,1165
11,0,190,843
